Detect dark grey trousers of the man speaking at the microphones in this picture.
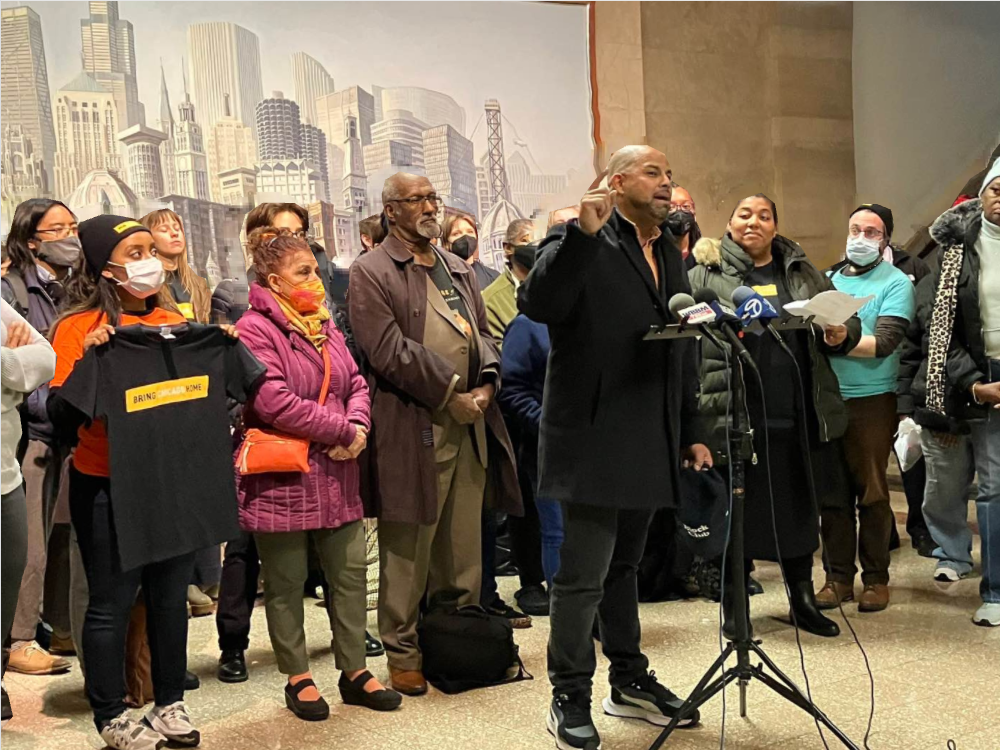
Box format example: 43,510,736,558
549,503,653,697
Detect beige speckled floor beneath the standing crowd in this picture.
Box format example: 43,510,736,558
3,496,1000,750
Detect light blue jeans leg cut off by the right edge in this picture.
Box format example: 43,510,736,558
971,360,1000,604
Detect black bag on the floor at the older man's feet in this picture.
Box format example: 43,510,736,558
418,605,534,695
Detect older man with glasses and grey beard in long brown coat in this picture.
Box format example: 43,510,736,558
348,173,522,696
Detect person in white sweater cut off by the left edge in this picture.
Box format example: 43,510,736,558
0,300,56,721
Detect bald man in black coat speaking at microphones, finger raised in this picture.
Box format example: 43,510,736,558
518,146,712,750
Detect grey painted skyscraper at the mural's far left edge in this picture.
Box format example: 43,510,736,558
0,6,56,189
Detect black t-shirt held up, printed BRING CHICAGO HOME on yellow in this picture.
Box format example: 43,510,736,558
59,324,265,570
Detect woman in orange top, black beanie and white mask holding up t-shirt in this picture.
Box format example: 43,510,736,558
48,216,200,750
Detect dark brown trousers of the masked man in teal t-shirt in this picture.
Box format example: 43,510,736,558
822,393,899,586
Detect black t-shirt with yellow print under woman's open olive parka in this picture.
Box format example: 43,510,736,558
743,261,810,429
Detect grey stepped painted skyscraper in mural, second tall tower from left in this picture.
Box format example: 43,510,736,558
80,0,146,127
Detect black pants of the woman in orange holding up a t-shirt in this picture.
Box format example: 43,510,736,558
70,470,194,729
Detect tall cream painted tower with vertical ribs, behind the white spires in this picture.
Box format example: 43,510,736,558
187,21,264,135
